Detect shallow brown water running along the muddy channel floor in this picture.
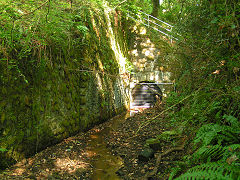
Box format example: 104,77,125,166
88,113,129,180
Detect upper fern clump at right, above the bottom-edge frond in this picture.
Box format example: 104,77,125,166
192,115,240,163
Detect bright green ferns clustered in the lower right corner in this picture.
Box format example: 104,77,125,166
171,115,240,180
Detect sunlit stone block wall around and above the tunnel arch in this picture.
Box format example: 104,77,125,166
128,25,174,96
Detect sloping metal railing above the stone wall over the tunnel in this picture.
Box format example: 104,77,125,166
127,10,180,42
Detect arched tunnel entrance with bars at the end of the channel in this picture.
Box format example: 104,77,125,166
130,81,162,112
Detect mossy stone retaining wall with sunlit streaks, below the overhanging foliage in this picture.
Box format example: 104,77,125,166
0,3,128,168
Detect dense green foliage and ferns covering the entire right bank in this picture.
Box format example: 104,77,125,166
159,0,240,179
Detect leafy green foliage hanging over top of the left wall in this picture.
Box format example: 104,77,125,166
0,1,84,84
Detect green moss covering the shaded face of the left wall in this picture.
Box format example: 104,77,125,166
0,1,129,169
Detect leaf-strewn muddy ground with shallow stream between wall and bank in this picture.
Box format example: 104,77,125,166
0,107,189,180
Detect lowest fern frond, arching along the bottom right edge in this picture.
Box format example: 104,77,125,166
176,162,240,180
